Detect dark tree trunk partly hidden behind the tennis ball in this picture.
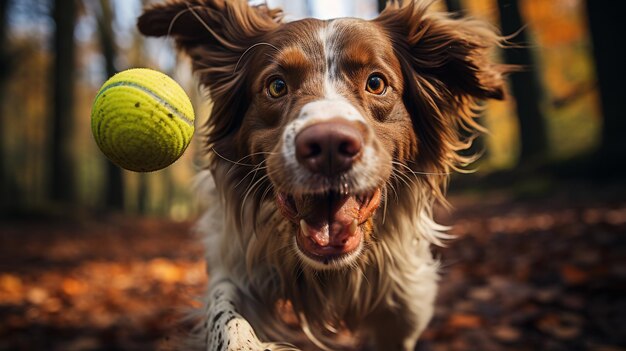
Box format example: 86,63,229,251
98,0,124,210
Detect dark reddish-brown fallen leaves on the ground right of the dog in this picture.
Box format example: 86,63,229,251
418,190,626,351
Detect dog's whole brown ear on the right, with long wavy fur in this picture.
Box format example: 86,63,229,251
374,0,510,179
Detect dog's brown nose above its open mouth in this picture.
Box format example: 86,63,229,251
295,120,363,176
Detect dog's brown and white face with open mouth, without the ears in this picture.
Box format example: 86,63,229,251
238,19,404,267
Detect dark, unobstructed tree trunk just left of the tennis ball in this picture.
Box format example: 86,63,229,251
49,0,76,203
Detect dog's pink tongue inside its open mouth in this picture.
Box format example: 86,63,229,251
296,195,361,246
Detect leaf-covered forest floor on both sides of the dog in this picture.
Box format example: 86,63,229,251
0,184,626,351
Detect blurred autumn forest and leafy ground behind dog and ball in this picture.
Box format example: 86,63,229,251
0,0,626,351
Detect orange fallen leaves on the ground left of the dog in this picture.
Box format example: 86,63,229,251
0,218,202,351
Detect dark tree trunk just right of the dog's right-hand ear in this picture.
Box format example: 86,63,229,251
498,0,548,165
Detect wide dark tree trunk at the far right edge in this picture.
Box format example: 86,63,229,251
587,0,626,170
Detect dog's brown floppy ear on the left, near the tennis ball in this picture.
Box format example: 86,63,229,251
137,0,282,141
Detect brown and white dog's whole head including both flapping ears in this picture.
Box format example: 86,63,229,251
139,0,503,268
